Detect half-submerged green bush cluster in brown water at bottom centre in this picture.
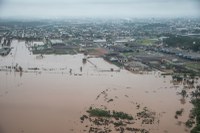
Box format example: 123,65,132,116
80,107,153,133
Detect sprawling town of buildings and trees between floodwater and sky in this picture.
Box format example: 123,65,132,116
0,18,200,75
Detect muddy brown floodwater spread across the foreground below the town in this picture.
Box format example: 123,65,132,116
0,41,197,133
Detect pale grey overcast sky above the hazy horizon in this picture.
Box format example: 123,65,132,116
0,0,200,18
